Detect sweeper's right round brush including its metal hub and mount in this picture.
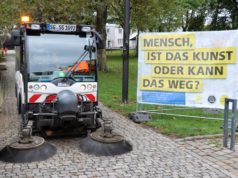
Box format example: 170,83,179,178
79,120,132,156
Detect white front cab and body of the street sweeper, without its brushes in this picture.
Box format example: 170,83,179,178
15,24,102,130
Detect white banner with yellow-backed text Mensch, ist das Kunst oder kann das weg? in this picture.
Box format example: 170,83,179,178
137,30,238,108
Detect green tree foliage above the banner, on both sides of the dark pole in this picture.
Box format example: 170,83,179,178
109,0,238,32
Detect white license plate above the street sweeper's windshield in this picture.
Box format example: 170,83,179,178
47,24,76,32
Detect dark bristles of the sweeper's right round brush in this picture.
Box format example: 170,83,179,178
79,137,132,156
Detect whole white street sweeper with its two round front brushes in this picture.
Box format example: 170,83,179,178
0,18,132,162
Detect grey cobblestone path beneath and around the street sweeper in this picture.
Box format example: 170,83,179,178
0,52,235,178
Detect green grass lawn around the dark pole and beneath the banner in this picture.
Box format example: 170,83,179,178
99,50,223,137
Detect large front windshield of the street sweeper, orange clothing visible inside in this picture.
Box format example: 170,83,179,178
26,34,96,82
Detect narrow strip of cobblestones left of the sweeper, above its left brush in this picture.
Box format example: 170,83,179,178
0,51,20,148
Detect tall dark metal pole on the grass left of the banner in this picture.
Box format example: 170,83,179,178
122,0,130,103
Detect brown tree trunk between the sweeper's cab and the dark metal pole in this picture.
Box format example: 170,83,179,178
96,0,108,71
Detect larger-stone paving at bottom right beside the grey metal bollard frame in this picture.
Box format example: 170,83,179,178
176,136,238,177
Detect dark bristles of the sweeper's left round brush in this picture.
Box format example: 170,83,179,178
0,142,56,163
